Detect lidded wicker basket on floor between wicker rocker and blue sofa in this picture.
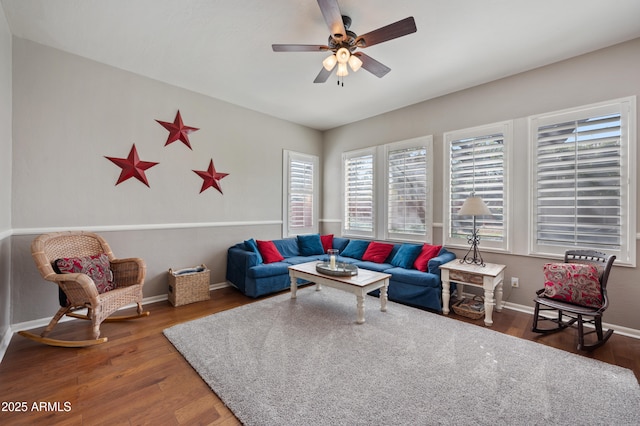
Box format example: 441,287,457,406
168,264,211,306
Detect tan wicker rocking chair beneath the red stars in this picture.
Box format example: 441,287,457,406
18,231,149,347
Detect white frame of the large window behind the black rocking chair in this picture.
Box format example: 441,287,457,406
528,96,637,267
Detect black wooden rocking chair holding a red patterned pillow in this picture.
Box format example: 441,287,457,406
531,250,616,351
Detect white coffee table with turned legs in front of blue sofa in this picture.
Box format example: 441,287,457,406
289,262,391,324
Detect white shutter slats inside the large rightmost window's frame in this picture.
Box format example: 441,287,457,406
536,114,622,246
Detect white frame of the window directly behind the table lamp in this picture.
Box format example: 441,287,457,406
442,120,514,253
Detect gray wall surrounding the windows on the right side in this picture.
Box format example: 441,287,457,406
323,39,640,330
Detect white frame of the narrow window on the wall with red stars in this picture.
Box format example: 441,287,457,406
282,149,320,238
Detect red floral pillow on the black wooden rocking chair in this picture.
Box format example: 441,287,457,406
544,263,603,308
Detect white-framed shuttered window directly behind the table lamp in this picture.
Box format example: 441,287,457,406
444,122,513,251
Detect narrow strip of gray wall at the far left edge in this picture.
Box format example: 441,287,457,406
0,5,12,340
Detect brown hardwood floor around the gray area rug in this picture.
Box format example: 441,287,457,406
0,288,640,425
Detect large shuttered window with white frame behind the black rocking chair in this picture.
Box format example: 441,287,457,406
530,98,636,265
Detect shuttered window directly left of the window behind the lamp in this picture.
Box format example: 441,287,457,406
385,140,433,241
